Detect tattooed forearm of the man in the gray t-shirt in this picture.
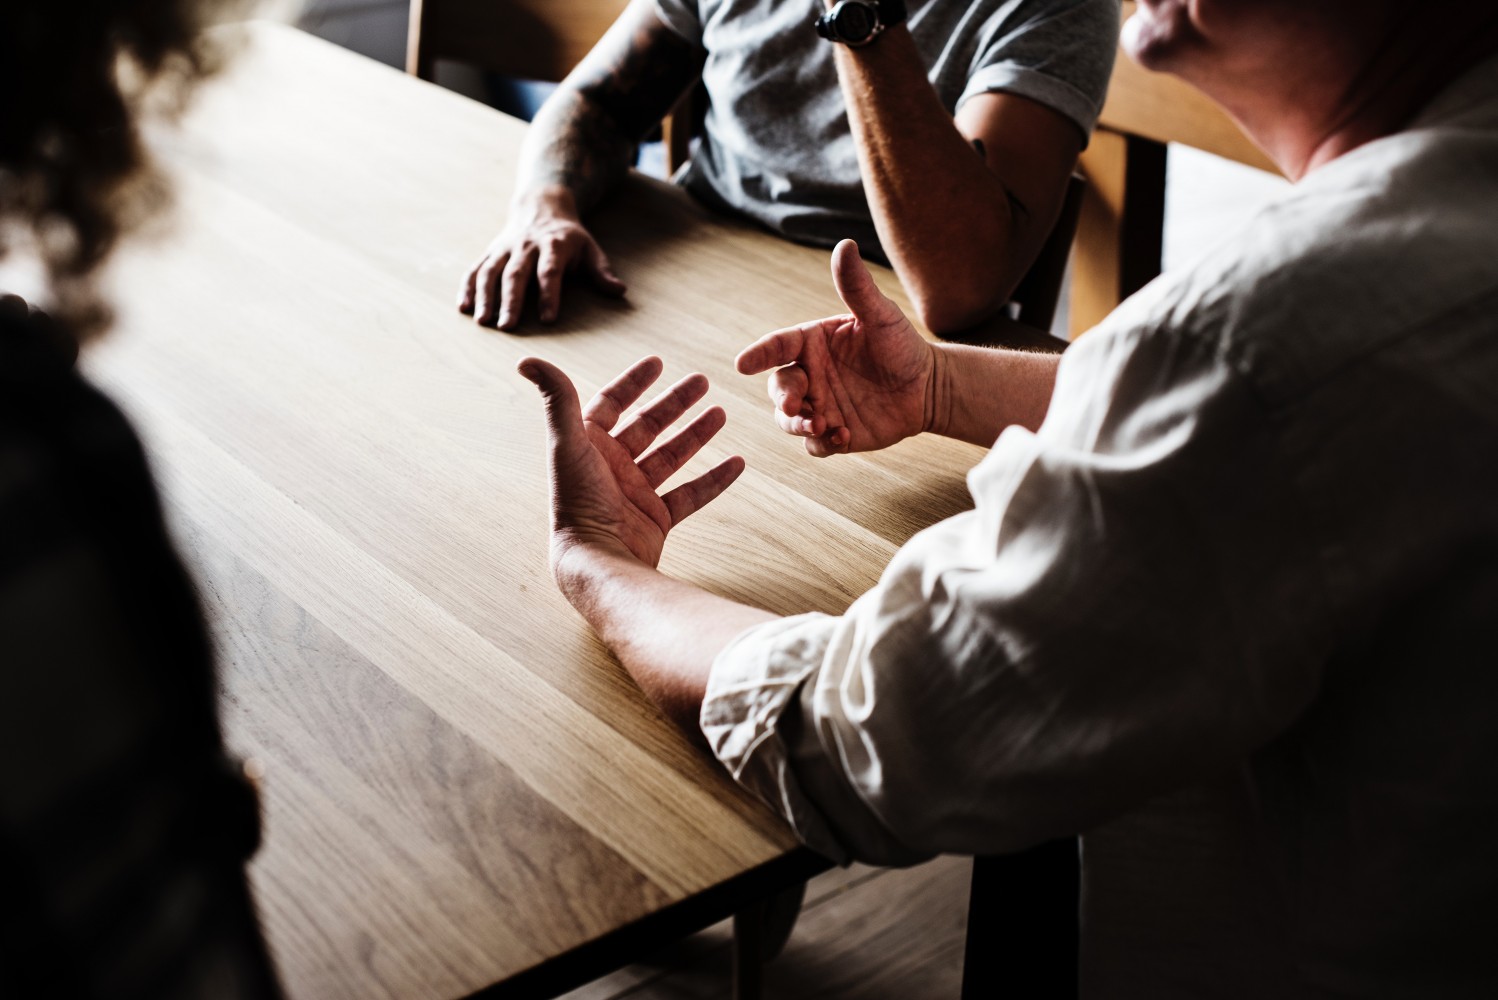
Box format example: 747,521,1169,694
520,0,706,211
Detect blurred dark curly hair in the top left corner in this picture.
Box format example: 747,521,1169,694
0,0,239,340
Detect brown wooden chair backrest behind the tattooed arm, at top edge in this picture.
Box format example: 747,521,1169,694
406,0,628,82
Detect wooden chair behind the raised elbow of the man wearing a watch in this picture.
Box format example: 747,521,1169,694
1070,3,1278,337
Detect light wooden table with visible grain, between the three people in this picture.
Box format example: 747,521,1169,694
85,25,980,999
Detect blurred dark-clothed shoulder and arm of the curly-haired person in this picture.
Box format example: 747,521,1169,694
0,298,277,997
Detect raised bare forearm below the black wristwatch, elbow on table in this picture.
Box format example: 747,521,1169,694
836,27,1019,332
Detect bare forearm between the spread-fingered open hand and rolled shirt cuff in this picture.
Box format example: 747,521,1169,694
557,546,774,741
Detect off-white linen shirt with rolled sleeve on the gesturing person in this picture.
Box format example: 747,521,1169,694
701,61,1498,996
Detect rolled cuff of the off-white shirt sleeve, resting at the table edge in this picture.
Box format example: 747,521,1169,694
698,614,849,865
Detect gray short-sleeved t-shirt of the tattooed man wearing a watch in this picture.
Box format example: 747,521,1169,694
655,0,1119,257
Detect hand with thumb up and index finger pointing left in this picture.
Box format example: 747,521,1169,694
737,240,935,457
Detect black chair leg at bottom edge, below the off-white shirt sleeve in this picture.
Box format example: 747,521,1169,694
962,837,1082,1000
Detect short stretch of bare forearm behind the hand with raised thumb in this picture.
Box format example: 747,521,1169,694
930,344,1061,448
